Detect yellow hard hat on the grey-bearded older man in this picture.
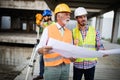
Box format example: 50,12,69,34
54,3,71,14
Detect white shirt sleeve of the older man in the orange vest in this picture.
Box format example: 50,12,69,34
36,27,48,51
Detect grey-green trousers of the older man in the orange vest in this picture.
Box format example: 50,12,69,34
44,63,70,80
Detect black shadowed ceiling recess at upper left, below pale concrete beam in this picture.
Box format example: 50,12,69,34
0,8,43,19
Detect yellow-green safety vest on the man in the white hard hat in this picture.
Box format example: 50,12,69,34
73,26,97,62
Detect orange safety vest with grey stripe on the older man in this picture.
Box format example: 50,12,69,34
44,24,72,66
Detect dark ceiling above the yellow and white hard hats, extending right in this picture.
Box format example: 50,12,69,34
45,0,120,18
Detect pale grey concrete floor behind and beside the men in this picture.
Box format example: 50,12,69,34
15,41,120,80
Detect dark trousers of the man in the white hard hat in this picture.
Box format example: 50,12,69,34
73,66,95,80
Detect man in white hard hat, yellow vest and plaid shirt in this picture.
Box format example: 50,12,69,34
73,7,107,80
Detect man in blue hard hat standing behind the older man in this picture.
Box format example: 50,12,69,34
33,9,55,80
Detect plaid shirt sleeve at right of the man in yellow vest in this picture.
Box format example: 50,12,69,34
96,30,104,50
